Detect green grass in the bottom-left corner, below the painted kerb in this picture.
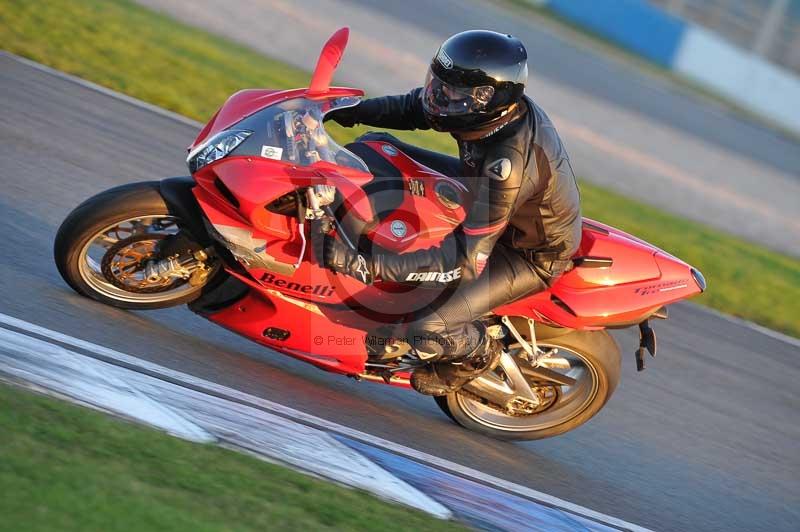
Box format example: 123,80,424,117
0,384,463,532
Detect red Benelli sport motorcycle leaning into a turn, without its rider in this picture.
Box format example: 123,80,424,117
55,28,705,439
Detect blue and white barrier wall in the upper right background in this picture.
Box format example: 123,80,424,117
536,0,800,133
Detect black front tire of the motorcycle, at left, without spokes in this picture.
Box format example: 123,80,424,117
53,181,224,310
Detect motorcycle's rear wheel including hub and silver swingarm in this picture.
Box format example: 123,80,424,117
435,331,621,440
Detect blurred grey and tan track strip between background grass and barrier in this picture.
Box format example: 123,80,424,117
137,0,800,256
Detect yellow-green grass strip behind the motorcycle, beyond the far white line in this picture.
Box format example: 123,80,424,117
0,0,800,336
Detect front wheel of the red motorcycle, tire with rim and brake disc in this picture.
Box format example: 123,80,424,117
53,181,219,310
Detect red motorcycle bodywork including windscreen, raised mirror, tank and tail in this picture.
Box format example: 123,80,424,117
184,28,702,385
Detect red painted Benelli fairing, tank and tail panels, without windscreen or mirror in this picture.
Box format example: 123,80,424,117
195,134,700,374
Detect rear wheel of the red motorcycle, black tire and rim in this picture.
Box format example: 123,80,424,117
435,331,621,440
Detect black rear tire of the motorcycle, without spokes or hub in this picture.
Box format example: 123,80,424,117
435,331,622,440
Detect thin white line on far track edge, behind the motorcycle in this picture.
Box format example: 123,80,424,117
0,50,800,347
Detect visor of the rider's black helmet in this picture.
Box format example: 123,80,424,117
422,69,494,116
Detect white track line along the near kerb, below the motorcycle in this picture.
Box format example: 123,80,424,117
0,313,647,531
